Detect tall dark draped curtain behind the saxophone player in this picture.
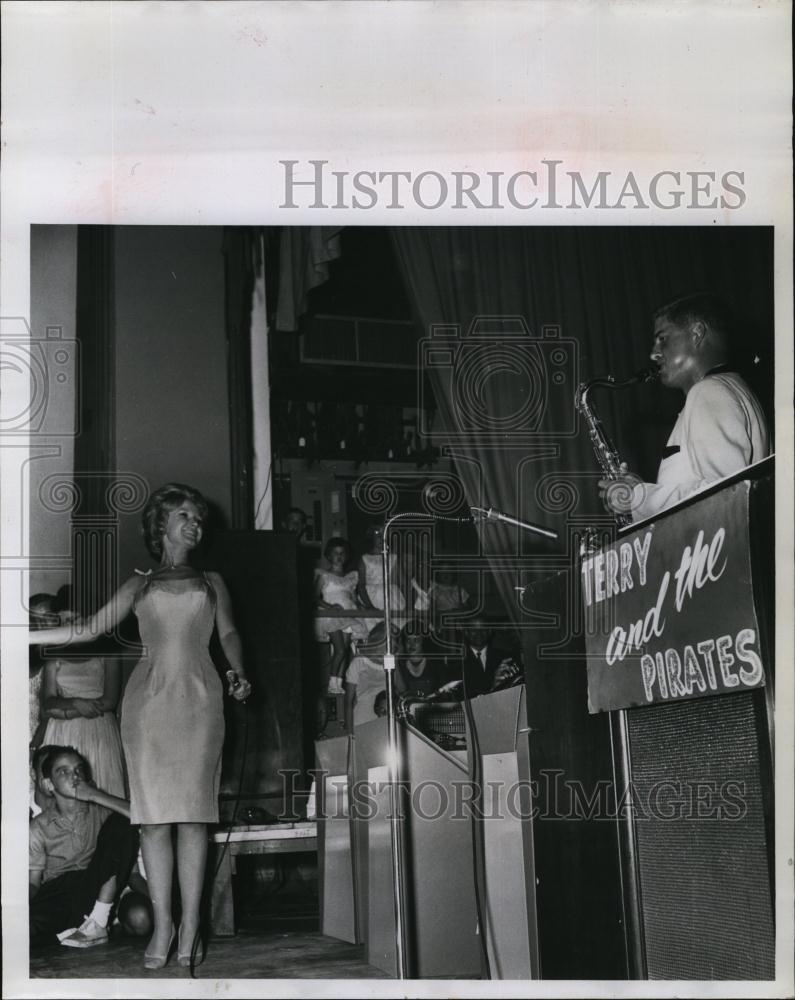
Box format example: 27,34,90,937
391,227,773,614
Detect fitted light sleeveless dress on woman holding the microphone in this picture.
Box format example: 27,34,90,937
121,576,224,823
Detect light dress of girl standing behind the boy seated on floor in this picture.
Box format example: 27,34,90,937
42,657,126,799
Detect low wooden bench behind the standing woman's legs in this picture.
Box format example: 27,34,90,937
208,821,317,937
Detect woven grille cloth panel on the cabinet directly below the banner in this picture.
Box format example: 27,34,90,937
627,693,775,979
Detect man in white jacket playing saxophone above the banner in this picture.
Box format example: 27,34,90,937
599,293,770,521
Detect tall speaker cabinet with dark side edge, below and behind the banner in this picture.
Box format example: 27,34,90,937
611,470,775,980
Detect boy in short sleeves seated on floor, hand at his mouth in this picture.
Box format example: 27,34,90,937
28,746,138,948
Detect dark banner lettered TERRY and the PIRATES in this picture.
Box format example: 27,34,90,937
580,482,765,713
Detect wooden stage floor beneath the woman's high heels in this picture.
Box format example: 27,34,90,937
30,921,388,980
